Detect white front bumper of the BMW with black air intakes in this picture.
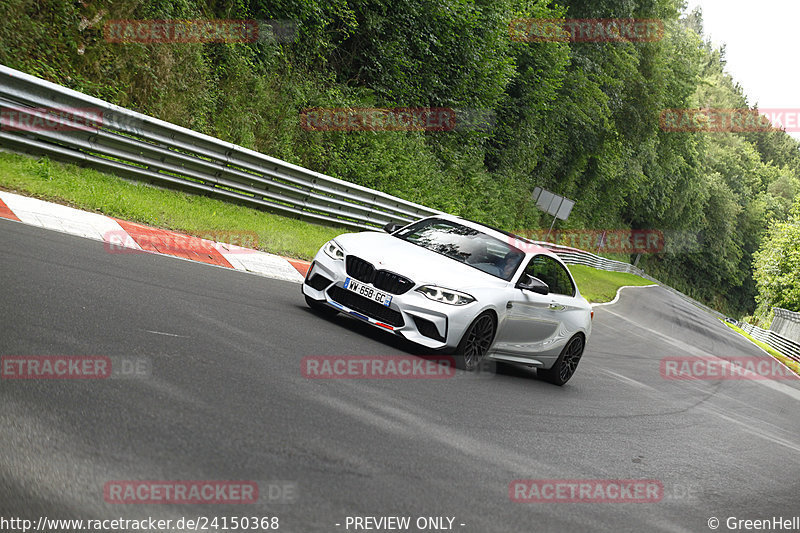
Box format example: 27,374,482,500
302,251,478,350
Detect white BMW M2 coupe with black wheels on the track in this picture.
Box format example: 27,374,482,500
302,215,593,385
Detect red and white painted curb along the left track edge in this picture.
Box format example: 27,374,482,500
0,191,310,283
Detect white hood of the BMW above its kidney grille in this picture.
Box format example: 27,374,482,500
334,231,508,289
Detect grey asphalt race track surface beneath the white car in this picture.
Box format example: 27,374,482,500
0,220,800,533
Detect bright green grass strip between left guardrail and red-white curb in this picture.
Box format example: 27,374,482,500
0,152,347,259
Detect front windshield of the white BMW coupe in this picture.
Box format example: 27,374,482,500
394,218,525,281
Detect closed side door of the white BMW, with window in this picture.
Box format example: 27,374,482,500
495,255,575,355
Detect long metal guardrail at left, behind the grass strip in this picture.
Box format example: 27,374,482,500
0,65,440,228
